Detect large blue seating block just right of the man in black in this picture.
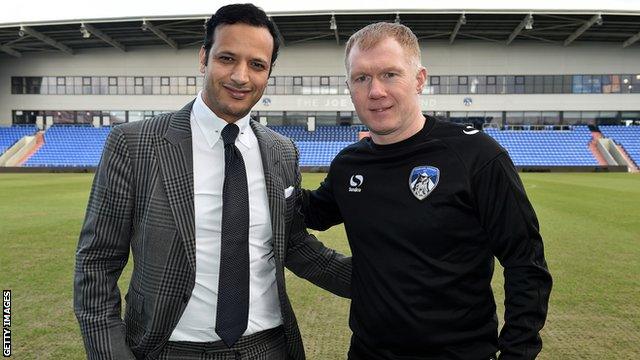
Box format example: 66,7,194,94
485,126,598,166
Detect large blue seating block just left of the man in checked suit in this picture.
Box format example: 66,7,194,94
24,125,111,167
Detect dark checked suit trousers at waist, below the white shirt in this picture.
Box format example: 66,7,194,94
158,326,287,360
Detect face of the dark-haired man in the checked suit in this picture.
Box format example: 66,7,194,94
200,23,273,122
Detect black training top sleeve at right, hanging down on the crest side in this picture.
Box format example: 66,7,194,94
471,153,552,360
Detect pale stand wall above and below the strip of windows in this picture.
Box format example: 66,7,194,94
0,40,640,125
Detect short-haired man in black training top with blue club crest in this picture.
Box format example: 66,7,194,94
305,23,551,360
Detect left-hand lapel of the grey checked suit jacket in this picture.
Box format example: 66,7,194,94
156,101,196,271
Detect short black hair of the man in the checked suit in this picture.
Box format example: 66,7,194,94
202,4,280,73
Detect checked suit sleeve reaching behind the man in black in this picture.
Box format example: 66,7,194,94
285,141,351,298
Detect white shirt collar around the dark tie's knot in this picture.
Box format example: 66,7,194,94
192,90,252,149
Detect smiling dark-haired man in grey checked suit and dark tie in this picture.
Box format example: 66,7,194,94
74,4,351,360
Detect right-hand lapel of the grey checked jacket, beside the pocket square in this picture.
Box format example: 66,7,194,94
250,120,286,263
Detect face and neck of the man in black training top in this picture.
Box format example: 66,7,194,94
347,38,427,144
